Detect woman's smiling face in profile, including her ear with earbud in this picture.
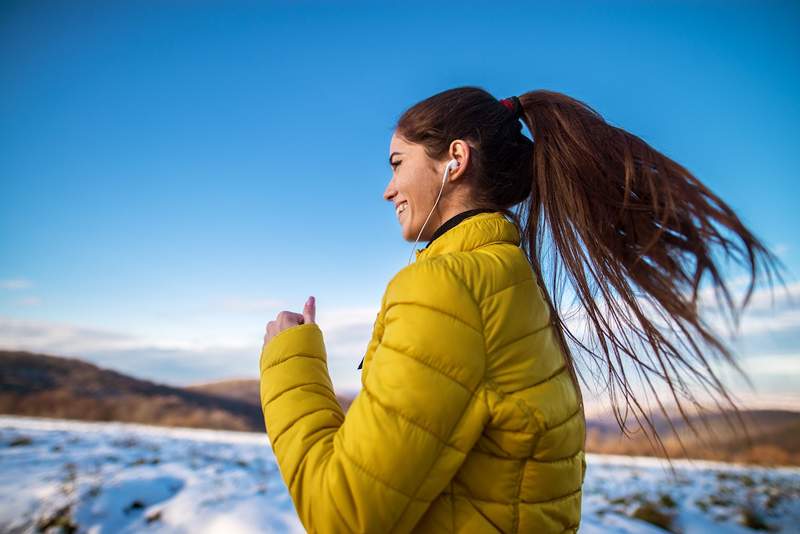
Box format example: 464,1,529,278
383,132,468,241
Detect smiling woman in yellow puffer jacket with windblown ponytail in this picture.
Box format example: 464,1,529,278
260,87,777,533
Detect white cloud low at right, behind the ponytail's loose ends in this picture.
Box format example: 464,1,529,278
548,276,800,416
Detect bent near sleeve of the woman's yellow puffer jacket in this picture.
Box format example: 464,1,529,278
260,262,488,533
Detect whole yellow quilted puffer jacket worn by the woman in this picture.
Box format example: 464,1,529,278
260,212,586,534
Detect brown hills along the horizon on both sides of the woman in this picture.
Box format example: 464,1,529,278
0,350,800,465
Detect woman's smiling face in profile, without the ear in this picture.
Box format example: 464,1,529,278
383,132,452,241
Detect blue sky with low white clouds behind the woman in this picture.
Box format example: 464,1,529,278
0,1,800,406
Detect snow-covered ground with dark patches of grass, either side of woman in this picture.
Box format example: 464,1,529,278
0,416,800,534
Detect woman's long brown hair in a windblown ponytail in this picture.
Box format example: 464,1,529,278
396,87,783,465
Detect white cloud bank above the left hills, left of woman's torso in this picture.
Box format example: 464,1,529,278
0,307,378,391
